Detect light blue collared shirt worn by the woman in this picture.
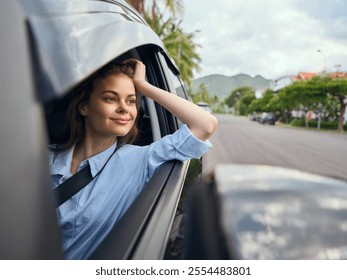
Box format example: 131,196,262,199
51,124,212,259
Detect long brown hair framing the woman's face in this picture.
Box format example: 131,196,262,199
63,60,139,150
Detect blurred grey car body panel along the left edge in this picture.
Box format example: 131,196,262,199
0,0,63,260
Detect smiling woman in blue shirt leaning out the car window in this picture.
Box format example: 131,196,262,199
51,59,217,259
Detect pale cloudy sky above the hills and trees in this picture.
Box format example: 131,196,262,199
180,0,347,79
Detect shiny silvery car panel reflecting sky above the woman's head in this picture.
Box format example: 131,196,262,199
22,0,164,100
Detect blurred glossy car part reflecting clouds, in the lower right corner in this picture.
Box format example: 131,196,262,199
214,165,347,259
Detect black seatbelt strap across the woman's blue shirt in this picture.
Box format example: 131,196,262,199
53,146,118,207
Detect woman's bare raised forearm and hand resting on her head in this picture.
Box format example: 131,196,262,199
133,61,218,141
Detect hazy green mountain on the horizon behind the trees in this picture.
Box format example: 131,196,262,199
191,74,270,100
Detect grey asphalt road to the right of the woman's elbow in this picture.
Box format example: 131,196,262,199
203,115,347,180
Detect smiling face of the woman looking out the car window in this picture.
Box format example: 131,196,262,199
79,74,137,141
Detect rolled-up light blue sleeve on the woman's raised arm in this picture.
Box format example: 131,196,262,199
148,124,212,175
